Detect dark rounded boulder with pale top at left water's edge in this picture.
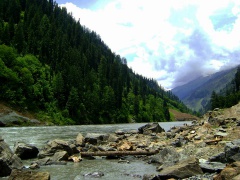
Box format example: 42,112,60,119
14,142,39,159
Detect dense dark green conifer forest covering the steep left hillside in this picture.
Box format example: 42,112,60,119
0,0,191,124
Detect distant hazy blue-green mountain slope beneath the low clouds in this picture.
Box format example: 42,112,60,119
172,68,237,112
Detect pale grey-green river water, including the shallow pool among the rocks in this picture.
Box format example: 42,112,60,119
0,121,191,180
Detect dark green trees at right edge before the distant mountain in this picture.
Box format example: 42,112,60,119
210,67,240,110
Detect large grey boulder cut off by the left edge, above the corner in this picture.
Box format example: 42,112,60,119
0,138,23,177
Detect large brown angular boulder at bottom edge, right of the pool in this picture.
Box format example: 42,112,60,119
158,157,203,179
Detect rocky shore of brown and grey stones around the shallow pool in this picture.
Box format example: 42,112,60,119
0,105,240,180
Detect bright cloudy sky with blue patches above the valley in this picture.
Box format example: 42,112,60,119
56,0,240,89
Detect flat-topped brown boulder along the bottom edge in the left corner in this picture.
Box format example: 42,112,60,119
9,169,50,180
